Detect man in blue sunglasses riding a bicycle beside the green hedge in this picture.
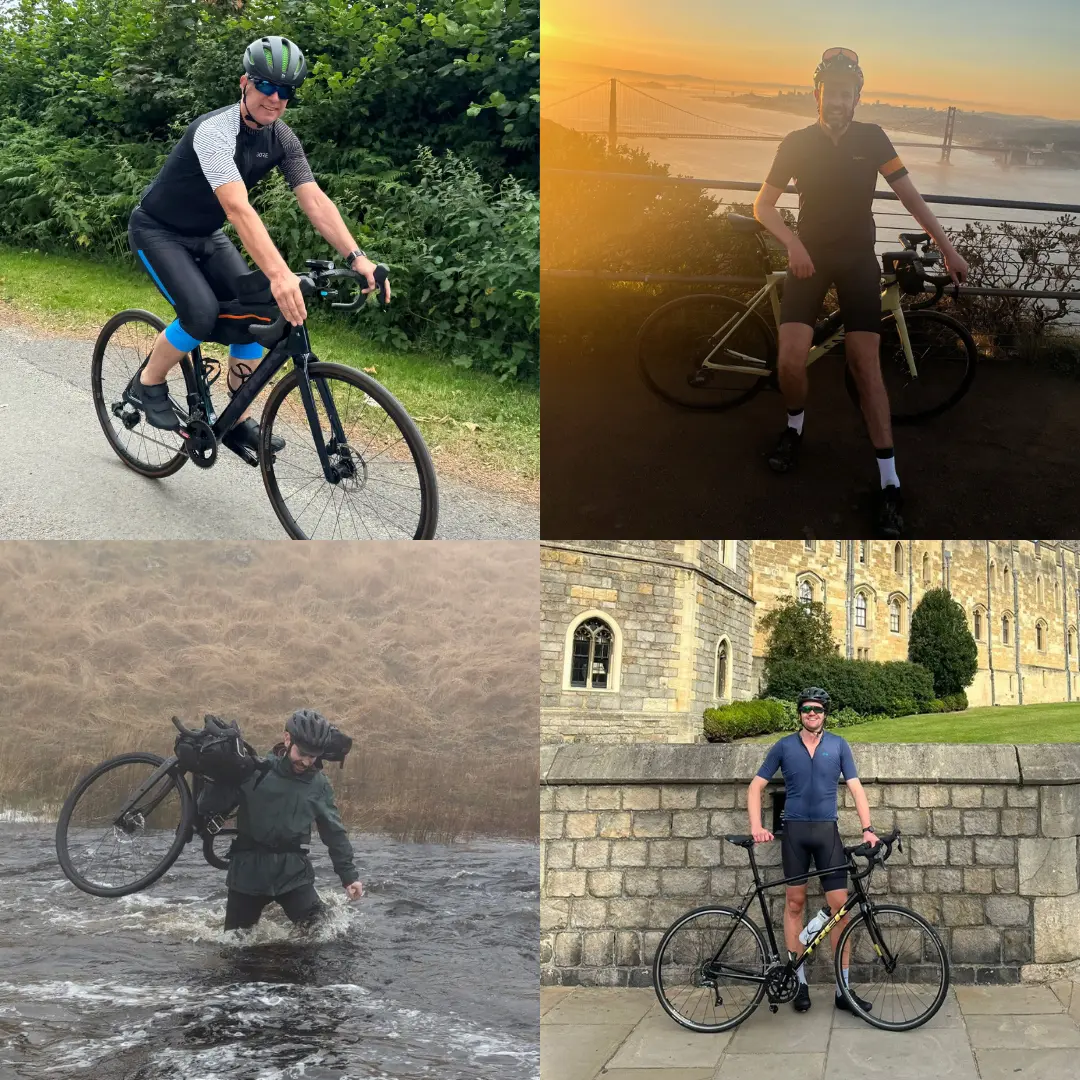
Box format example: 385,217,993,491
124,35,390,453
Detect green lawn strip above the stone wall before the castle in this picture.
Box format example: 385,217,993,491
748,701,1080,743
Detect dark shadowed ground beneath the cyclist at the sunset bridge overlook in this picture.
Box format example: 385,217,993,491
541,287,1080,539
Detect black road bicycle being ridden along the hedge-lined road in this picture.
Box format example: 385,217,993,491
92,259,438,540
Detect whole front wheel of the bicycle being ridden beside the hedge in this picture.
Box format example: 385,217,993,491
259,363,438,540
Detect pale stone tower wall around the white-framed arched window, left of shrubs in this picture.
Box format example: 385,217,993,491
540,540,754,742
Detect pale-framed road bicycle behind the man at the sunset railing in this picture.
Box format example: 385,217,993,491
637,214,978,423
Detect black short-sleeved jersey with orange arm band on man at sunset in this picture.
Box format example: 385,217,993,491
765,121,907,249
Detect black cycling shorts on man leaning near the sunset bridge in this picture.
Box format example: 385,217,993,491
780,247,881,334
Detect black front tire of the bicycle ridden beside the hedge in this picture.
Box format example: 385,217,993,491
259,362,438,540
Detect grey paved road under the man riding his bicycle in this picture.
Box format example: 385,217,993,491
0,327,540,540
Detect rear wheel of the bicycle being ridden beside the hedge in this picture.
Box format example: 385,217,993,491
91,308,194,478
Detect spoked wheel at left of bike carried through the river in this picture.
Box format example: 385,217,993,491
56,753,194,896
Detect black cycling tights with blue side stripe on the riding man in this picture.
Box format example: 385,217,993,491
127,206,253,345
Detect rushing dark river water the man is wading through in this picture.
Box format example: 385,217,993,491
0,821,540,1080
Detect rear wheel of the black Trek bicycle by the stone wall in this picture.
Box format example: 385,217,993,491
652,905,766,1031
